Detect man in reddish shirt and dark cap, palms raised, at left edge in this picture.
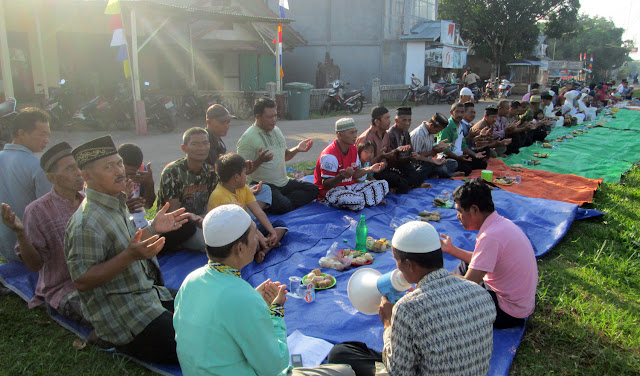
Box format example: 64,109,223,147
2,142,90,326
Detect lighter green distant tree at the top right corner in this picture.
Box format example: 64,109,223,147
548,15,633,81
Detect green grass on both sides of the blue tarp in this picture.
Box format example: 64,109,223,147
0,166,640,375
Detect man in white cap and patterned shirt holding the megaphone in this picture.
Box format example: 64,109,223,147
329,221,496,376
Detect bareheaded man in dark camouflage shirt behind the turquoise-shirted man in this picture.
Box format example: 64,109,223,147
158,127,218,252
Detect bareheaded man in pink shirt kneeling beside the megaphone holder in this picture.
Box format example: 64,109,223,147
440,179,538,329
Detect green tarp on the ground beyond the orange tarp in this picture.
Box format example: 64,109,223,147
504,110,640,183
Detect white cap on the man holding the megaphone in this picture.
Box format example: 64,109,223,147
391,221,441,253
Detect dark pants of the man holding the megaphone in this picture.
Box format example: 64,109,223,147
327,342,382,376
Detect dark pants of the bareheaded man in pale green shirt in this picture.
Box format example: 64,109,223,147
265,179,319,214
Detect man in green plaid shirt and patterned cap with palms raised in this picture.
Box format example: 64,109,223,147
64,136,189,363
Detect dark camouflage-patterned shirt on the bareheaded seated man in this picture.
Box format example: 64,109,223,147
158,158,218,216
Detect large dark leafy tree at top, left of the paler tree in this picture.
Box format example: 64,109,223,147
439,0,580,74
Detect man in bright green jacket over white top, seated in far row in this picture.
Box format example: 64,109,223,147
438,102,487,175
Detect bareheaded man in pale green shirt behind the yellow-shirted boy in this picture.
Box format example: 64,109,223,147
237,98,318,214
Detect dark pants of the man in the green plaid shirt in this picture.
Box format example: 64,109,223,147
117,300,178,364
